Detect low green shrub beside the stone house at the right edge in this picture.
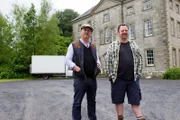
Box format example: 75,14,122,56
162,67,180,80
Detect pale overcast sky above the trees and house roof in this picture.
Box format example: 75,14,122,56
0,0,100,15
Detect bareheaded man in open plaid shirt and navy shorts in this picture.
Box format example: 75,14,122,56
105,24,145,120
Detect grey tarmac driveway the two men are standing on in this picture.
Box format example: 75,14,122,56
0,78,180,120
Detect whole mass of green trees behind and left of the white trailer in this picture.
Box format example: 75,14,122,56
0,0,78,78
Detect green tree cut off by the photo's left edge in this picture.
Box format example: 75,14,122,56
0,13,14,78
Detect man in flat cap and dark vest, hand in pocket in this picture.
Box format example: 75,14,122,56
65,24,100,120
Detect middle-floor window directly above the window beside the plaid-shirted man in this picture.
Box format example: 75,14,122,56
144,20,153,37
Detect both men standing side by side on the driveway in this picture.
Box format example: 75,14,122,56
66,24,145,120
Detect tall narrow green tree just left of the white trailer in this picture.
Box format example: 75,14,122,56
11,4,37,73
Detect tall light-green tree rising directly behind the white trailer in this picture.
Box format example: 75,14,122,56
36,0,59,55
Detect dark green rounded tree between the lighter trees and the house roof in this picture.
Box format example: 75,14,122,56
56,9,79,37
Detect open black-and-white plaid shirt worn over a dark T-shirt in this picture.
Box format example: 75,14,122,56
105,40,143,82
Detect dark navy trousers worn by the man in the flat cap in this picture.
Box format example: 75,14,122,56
72,78,97,120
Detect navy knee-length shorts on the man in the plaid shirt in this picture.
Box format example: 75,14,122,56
111,78,141,105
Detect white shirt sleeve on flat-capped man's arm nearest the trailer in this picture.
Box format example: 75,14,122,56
65,43,76,70
